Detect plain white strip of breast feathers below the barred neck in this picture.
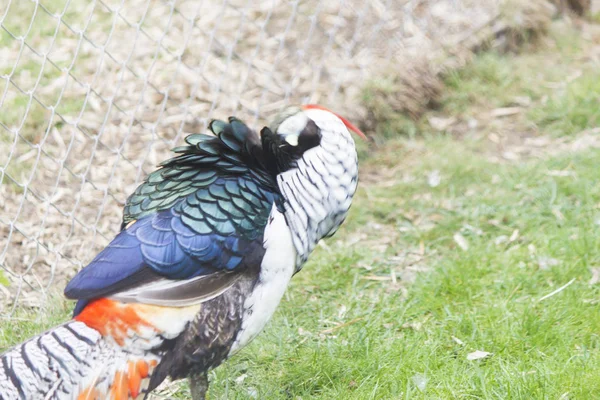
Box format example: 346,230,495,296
230,207,296,355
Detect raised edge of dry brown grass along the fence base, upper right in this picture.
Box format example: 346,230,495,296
361,0,556,134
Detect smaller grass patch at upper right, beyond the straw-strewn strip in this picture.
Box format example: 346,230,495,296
442,24,600,136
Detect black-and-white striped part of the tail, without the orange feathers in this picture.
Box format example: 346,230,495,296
0,321,101,400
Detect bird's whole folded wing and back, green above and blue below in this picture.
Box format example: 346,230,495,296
65,119,280,314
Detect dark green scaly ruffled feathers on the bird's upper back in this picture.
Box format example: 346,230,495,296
122,118,278,228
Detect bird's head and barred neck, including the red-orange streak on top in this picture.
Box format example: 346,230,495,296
262,104,365,270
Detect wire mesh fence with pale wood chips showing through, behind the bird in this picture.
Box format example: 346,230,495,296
0,0,499,316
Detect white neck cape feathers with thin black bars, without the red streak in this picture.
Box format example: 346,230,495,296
277,109,358,271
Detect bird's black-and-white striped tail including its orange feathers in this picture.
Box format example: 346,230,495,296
0,300,188,400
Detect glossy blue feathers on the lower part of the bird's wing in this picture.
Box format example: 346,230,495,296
65,203,258,299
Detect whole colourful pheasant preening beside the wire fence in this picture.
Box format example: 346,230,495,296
0,104,366,400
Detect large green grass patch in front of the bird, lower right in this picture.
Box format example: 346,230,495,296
202,139,600,399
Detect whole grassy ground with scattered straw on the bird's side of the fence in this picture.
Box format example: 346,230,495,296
0,18,600,399
